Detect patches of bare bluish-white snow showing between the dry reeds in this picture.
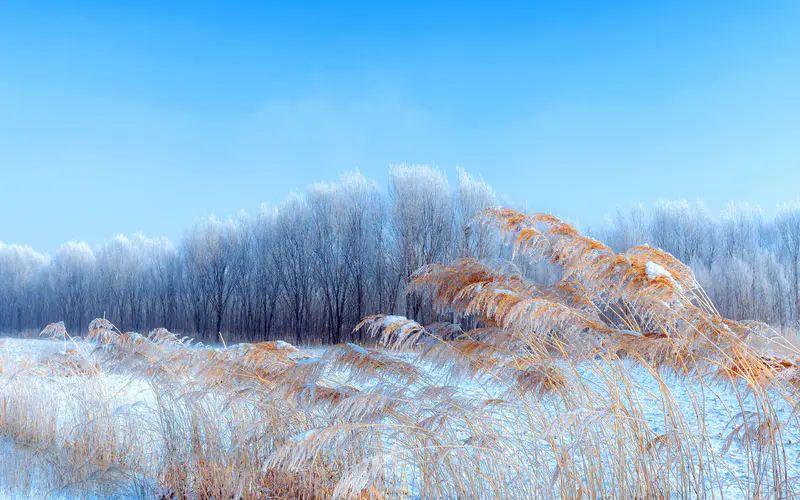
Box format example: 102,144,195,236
0,338,800,498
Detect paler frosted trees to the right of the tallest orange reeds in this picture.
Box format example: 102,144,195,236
596,201,800,327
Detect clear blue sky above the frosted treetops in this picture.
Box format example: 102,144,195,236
0,0,800,252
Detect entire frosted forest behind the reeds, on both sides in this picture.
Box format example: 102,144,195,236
0,166,800,343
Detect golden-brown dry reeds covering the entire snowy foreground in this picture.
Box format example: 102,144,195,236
0,209,800,499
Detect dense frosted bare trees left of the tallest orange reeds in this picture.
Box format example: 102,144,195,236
0,166,500,343
